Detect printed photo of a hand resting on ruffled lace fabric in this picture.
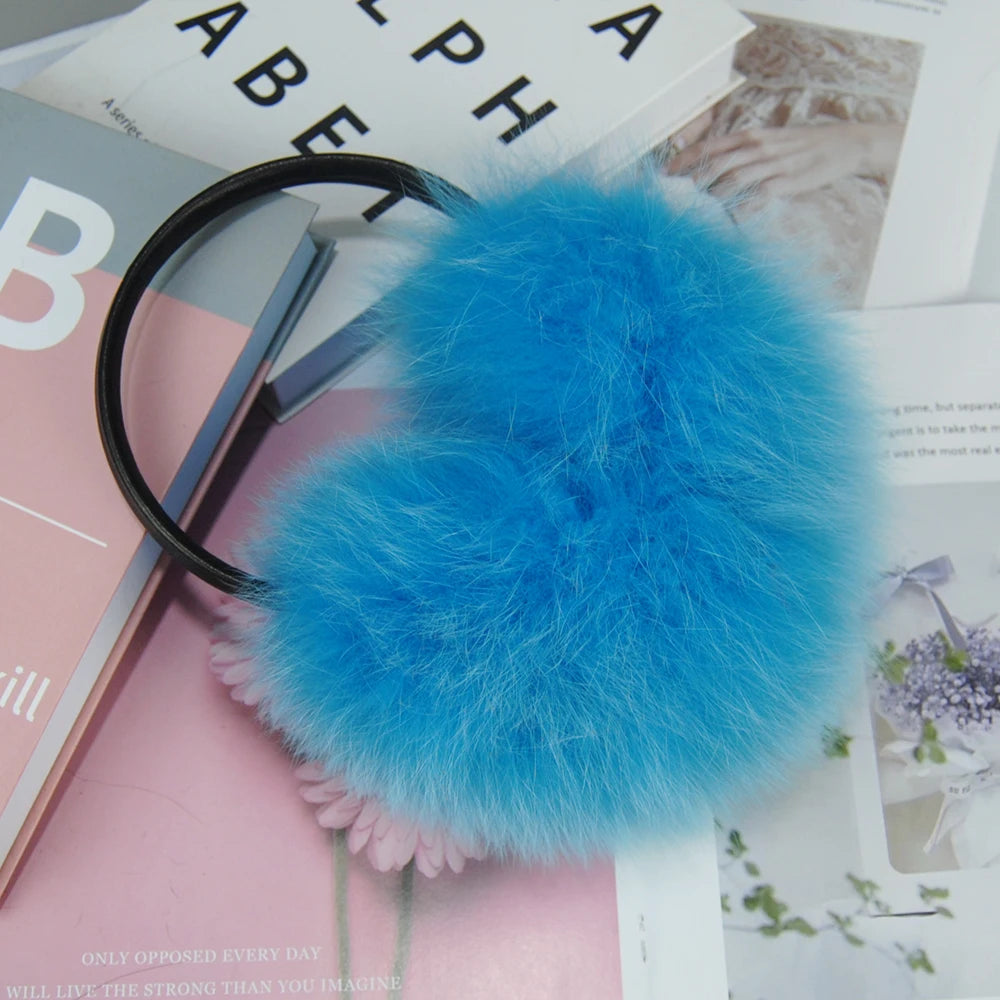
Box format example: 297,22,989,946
657,12,923,308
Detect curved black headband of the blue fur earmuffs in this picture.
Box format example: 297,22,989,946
96,153,471,598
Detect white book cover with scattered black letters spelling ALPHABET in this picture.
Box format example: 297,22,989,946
22,0,749,386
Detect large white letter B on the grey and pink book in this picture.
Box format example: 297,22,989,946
0,177,115,351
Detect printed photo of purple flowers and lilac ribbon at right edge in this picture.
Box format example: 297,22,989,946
868,483,1000,873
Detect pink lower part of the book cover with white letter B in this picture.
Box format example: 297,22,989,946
0,270,251,820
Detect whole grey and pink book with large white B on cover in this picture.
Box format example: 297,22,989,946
0,91,315,891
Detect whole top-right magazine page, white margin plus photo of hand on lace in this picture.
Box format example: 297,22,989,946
664,0,1000,308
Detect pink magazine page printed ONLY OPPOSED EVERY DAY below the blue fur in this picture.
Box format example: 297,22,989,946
0,389,622,1000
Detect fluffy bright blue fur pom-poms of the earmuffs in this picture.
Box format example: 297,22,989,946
240,170,874,860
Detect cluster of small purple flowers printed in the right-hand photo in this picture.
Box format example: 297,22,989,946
874,627,1000,735
